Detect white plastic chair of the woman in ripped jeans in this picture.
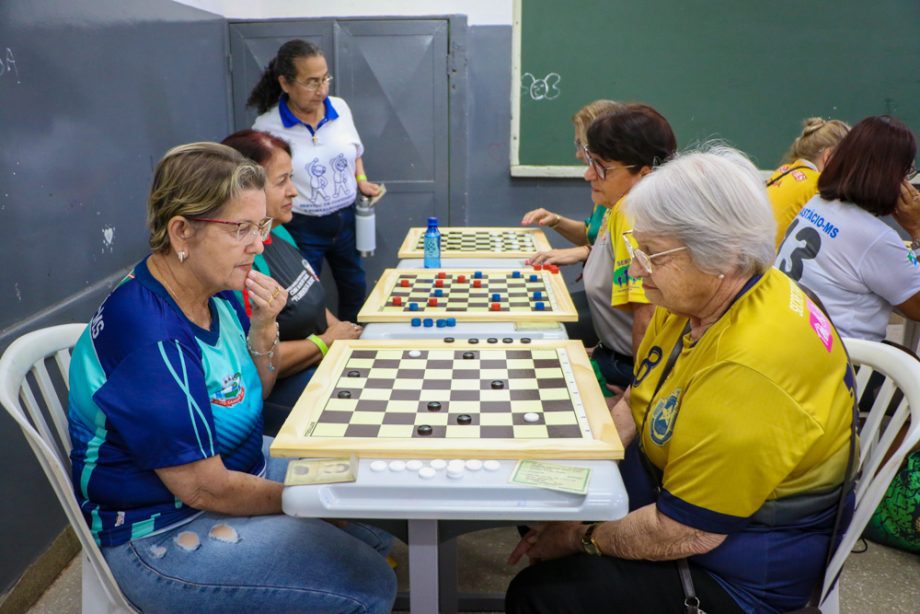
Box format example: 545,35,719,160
0,324,136,614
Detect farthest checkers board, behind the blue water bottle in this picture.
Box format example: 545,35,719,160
397,226,552,259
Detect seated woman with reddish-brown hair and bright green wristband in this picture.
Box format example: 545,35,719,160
223,130,361,435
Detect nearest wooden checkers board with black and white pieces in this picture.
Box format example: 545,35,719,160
271,340,623,459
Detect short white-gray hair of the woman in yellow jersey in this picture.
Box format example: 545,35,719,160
625,144,776,275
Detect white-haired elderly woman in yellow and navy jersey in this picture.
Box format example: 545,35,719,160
507,148,853,613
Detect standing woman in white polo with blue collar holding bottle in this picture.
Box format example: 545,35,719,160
247,40,380,321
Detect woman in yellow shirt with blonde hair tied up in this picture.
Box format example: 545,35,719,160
767,117,850,247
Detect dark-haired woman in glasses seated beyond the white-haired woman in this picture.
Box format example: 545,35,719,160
584,104,677,392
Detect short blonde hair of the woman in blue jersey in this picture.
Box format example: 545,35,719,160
147,142,265,252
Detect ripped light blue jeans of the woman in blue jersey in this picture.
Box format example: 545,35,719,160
102,438,396,614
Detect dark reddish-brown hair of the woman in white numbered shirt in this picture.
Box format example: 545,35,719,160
818,115,917,216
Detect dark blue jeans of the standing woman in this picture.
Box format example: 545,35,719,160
284,204,367,322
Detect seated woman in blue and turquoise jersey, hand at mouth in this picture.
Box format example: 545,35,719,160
68,143,396,612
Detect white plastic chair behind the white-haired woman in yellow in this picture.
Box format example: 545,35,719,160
820,339,920,614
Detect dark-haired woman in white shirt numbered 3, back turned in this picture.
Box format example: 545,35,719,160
776,115,920,341
